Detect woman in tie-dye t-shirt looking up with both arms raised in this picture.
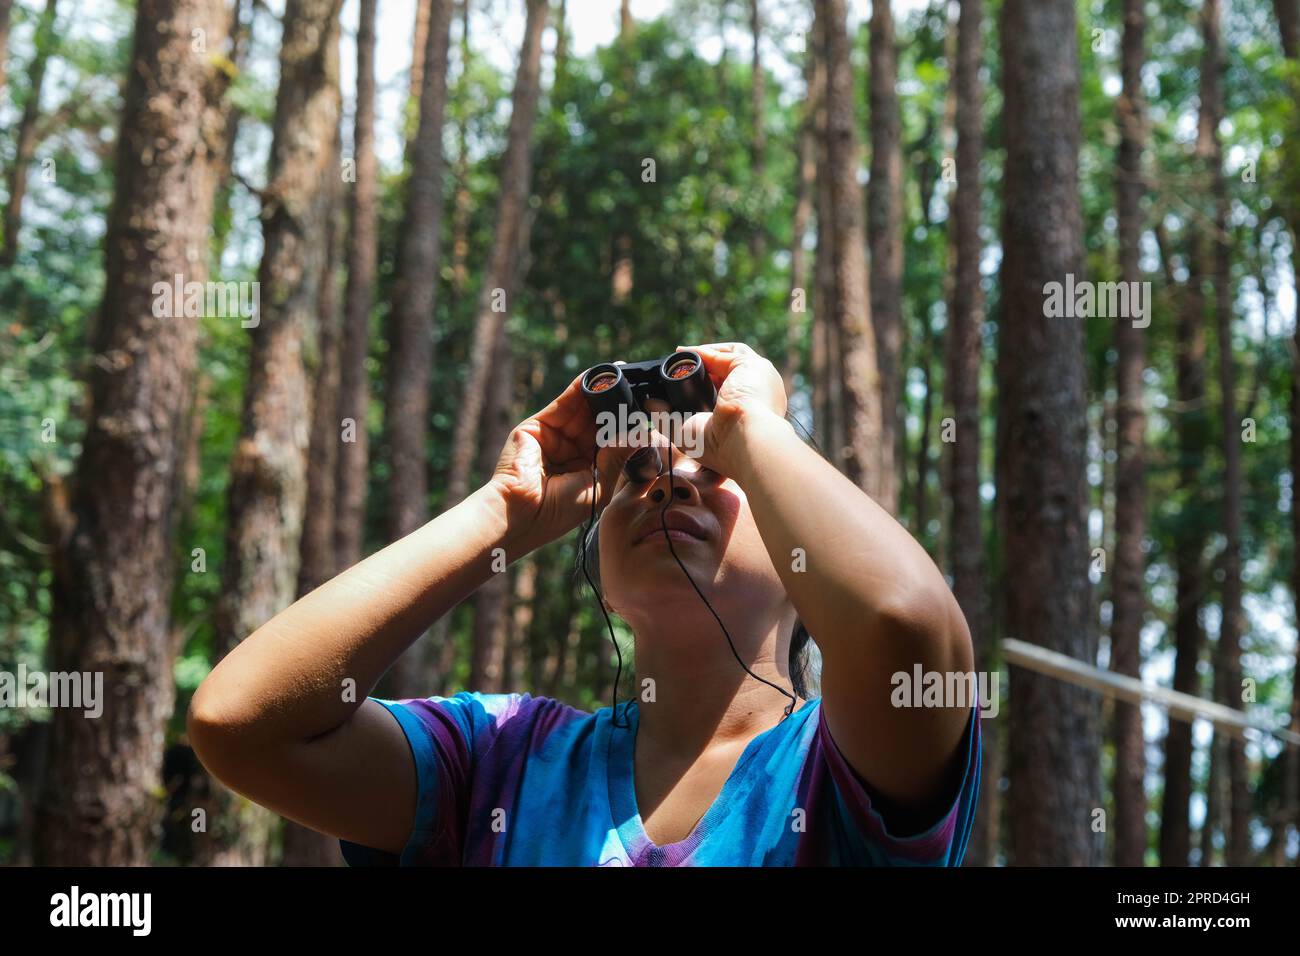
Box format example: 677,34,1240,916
189,343,980,866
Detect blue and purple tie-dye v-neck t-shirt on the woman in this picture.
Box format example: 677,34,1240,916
341,692,980,866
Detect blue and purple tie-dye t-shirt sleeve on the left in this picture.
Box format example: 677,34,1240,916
339,691,524,866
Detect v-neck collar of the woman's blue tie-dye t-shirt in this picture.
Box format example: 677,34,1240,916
605,698,816,866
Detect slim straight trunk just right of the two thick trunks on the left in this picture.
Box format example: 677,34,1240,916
334,0,380,570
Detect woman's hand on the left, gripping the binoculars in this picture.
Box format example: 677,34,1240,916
489,375,634,559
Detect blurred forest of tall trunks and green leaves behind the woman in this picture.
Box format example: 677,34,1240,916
0,0,1300,866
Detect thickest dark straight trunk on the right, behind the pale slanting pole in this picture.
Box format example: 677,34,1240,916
993,0,1101,866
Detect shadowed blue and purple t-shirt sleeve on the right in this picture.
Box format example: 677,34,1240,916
816,702,982,866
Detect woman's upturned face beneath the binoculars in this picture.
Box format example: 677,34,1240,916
599,447,788,626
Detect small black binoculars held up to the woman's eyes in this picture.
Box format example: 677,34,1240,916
582,351,718,481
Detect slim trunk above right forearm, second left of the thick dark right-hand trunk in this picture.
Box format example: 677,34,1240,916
867,0,904,514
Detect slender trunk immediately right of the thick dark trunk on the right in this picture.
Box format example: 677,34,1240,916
1110,0,1147,866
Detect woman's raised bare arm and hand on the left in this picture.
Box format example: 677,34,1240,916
189,369,628,853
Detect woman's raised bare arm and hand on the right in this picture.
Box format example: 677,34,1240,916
690,343,974,805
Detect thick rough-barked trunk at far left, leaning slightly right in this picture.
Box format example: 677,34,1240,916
38,0,230,866
